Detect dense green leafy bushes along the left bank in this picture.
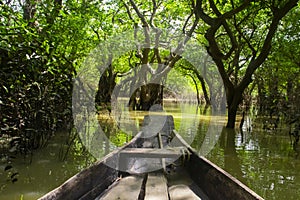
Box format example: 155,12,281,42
0,1,99,149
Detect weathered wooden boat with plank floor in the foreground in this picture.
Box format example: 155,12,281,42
40,117,263,200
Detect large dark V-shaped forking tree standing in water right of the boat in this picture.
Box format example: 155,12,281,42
194,0,298,128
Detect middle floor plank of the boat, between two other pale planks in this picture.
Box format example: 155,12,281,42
145,173,169,200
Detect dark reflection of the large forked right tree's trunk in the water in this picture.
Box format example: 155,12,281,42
220,127,244,182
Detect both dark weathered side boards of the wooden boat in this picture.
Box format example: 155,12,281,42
39,125,263,200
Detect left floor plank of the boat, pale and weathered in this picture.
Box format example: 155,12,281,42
99,176,143,200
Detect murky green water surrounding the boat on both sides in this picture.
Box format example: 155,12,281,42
0,103,300,200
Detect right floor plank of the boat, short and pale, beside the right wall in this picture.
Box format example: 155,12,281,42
169,184,201,200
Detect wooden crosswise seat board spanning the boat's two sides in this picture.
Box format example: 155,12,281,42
120,147,182,158
